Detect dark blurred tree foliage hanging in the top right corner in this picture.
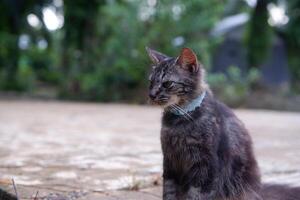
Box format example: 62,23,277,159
246,0,300,89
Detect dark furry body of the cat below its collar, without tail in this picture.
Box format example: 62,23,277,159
161,94,261,200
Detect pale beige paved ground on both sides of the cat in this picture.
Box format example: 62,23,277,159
0,100,300,200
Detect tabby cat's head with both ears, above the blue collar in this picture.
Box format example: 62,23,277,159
146,48,205,107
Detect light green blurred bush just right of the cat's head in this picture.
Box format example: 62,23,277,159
208,66,260,106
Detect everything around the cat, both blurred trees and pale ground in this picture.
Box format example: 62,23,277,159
0,0,300,200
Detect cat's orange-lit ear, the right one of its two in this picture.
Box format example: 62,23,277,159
176,48,199,73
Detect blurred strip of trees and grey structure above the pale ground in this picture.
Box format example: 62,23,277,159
0,0,300,110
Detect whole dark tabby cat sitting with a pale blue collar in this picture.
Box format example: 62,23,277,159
147,48,300,200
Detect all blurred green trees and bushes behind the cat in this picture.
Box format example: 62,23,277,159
0,0,300,105
